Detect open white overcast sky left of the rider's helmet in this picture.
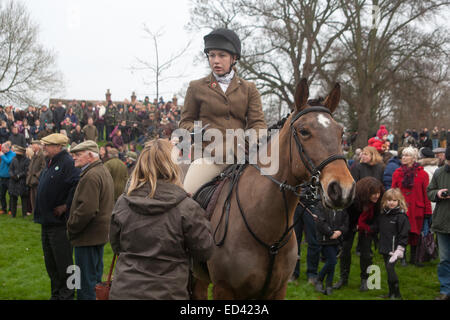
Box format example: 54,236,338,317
24,0,207,101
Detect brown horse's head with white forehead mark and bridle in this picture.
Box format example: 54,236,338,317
288,79,355,208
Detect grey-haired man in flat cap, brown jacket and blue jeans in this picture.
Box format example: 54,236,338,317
67,140,114,300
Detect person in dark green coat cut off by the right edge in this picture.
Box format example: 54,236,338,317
427,146,450,300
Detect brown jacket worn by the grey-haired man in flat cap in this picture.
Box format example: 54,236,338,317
67,160,114,247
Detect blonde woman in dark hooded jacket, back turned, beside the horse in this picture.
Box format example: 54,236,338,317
110,139,213,300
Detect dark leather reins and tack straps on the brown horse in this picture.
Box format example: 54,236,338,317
239,106,346,298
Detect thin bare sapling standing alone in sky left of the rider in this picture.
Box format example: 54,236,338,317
131,24,191,97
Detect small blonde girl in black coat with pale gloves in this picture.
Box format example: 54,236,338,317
377,189,410,299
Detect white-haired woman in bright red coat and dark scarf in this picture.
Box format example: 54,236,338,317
392,147,432,267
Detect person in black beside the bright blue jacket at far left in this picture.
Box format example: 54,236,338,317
8,145,30,218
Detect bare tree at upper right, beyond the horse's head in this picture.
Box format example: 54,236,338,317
321,0,449,146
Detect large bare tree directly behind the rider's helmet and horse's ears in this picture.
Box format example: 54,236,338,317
188,0,349,121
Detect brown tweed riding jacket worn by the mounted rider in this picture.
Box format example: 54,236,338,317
179,72,267,160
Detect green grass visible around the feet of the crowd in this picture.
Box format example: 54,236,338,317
0,209,439,300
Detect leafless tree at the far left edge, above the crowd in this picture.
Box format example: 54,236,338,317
0,1,63,104
